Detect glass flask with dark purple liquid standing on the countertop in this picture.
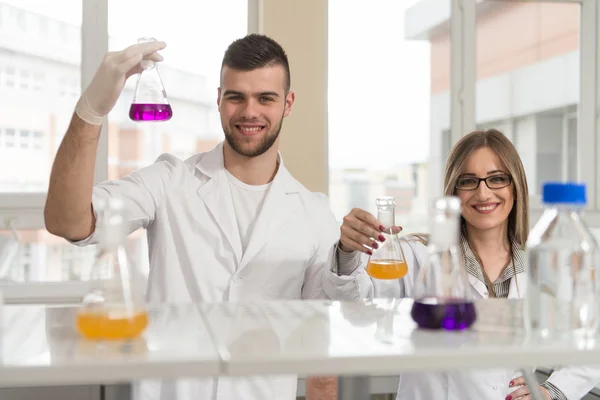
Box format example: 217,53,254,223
411,196,476,330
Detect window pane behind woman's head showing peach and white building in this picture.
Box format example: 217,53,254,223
475,1,581,202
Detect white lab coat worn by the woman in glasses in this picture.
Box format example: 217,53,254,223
326,238,600,400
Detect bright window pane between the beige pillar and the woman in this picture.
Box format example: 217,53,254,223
328,0,436,232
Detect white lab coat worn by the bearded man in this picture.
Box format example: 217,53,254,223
76,143,353,400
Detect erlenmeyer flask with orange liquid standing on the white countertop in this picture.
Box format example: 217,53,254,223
76,198,148,340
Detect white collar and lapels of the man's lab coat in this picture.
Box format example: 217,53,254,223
196,142,302,271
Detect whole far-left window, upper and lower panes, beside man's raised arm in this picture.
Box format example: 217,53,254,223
0,0,88,282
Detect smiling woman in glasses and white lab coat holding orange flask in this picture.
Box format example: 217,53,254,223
334,130,600,400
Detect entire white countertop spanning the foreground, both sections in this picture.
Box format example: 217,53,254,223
0,299,600,387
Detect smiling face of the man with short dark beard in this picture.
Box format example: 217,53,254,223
217,65,295,157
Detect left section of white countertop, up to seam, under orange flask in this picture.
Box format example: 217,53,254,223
0,305,221,387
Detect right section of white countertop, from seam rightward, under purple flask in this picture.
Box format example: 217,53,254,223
207,299,600,375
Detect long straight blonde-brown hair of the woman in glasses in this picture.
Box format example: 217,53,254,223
444,129,529,247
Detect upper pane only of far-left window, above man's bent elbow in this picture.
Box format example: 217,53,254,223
0,0,82,193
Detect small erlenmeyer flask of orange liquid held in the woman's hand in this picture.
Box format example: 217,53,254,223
367,196,408,279
